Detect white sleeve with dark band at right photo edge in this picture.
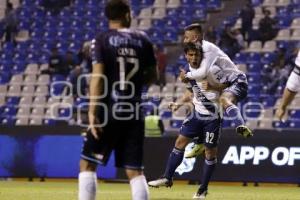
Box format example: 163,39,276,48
286,50,300,92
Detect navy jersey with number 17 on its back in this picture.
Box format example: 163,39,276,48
92,29,156,106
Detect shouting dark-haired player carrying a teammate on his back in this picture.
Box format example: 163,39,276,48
148,42,221,199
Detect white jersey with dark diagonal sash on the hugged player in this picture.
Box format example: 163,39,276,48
189,65,220,115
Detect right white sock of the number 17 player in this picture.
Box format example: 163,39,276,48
130,175,149,200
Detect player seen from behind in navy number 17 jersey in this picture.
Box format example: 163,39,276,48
79,0,157,200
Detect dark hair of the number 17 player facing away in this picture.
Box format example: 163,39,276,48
105,0,130,20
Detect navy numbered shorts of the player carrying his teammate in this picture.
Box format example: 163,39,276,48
180,111,222,148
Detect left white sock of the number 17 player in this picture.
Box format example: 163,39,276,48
78,171,97,200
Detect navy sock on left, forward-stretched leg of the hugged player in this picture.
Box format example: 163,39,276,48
164,147,184,179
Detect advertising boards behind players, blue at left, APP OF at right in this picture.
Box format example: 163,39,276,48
0,126,300,184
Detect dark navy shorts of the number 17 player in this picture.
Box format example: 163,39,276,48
81,120,144,169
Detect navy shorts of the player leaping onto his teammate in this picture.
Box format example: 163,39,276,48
224,75,248,101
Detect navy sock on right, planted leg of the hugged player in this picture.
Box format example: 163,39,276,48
200,158,217,191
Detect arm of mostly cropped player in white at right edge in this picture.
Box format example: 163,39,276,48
275,50,300,120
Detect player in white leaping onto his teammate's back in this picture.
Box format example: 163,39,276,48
183,23,253,157
